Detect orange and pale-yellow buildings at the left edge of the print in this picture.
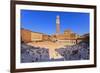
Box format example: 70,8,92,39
21,29,43,42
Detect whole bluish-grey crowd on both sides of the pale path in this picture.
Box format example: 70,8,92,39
21,42,89,63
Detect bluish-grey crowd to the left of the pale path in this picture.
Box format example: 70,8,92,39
21,44,49,63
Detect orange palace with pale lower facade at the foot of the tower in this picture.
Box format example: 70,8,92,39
52,30,77,45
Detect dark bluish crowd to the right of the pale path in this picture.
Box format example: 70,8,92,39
56,42,89,60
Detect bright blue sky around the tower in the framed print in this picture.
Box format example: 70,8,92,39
21,10,90,35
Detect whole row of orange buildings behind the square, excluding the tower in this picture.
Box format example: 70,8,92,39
21,29,81,44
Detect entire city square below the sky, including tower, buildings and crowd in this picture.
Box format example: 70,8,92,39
21,15,89,62
